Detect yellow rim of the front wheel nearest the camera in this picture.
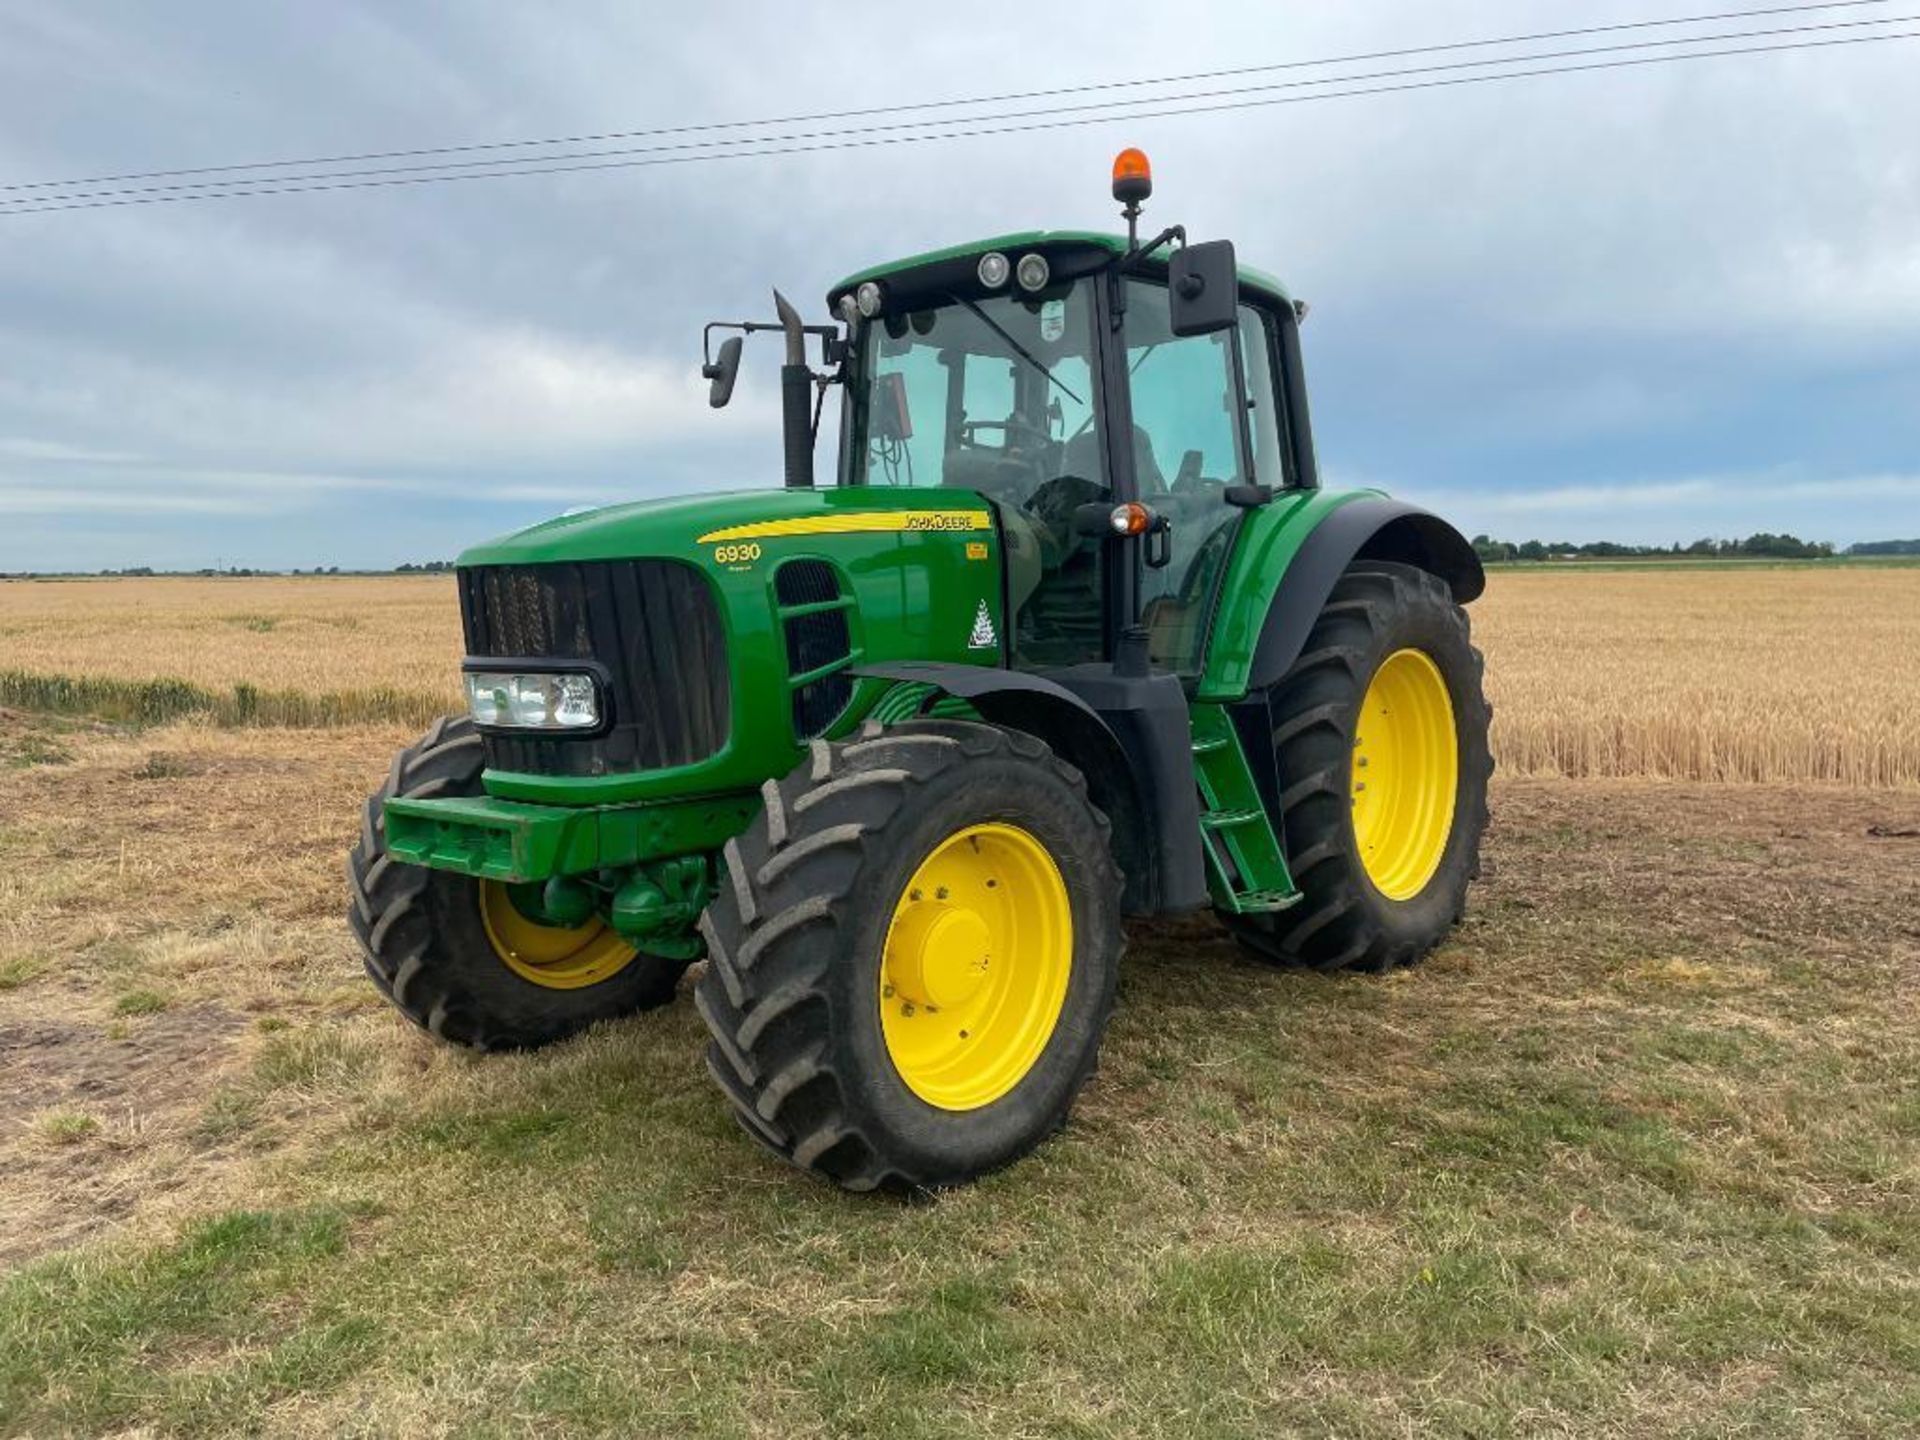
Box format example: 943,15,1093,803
879,824,1073,1110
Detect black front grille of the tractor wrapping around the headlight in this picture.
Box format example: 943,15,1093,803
459,561,732,776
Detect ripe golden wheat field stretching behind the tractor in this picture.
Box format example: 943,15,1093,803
0,566,1920,787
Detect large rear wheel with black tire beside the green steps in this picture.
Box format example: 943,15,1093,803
1223,561,1494,972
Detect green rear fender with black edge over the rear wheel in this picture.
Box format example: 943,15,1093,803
1196,490,1486,703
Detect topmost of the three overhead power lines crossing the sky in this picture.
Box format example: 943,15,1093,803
0,0,1895,198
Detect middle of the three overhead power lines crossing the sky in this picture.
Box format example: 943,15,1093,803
0,15,1914,215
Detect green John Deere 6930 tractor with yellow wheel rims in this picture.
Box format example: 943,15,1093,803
349,152,1492,1190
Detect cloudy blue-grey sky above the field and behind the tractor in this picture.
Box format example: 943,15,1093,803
0,0,1920,570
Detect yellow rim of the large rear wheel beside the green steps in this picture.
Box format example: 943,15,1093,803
1352,649,1459,900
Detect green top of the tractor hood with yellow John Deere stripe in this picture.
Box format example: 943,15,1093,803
457,486,993,568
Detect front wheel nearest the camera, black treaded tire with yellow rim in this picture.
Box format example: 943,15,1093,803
695,720,1121,1190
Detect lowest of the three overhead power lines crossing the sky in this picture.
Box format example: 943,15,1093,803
0,15,1920,217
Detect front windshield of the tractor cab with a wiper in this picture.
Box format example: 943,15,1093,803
841,278,1112,664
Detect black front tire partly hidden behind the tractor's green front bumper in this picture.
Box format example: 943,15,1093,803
348,716,687,1050
